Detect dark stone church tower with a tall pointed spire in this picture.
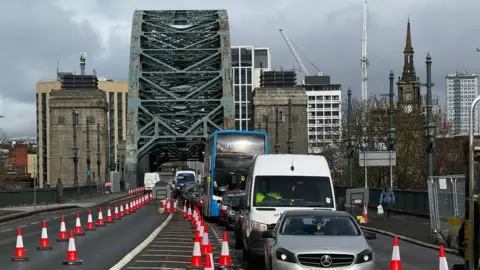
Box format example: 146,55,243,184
397,19,422,112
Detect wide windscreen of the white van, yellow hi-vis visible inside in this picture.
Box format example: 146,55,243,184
253,175,334,208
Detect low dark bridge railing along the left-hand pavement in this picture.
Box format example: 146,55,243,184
0,185,98,207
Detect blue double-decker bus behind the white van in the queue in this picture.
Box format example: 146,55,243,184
202,130,269,217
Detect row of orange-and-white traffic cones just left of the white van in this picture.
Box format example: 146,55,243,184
183,202,232,270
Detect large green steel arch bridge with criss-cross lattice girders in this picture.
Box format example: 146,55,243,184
125,10,234,184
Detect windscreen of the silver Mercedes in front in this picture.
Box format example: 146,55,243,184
280,213,361,236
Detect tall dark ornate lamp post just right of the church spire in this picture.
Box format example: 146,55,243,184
425,53,436,177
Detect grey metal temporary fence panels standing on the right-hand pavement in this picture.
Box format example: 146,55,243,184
427,175,465,241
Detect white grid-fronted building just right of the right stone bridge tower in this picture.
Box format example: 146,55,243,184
304,76,342,154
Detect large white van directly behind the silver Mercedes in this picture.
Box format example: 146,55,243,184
238,155,336,264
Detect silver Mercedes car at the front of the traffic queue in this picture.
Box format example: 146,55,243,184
262,210,376,270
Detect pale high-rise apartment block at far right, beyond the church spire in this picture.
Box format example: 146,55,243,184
445,73,480,134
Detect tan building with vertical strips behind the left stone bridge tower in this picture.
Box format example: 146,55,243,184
36,78,128,187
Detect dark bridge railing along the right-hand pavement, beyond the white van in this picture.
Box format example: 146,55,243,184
335,187,430,216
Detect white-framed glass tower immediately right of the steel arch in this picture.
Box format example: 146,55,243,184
232,46,272,130
